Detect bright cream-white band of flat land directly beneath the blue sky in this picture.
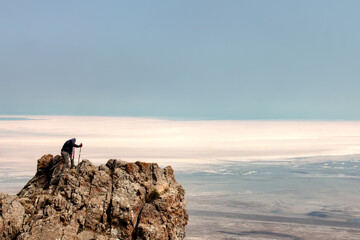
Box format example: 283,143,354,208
0,115,360,180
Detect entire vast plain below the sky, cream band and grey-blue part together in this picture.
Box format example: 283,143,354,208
0,116,360,239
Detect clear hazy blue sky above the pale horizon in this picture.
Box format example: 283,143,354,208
0,0,360,120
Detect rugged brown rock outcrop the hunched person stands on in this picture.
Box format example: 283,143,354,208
0,155,188,240
